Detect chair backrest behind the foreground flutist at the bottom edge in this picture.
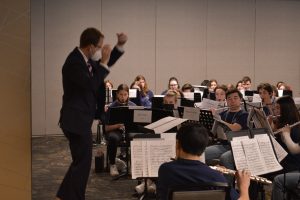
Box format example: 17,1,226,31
168,182,230,200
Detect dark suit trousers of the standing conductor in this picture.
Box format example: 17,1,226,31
57,130,93,200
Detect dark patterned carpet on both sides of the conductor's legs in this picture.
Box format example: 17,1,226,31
32,136,137,200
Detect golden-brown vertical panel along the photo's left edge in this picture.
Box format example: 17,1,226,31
0,0,31,200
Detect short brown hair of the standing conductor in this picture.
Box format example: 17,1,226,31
80,28,104,48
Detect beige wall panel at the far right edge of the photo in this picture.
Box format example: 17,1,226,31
255,1,300,97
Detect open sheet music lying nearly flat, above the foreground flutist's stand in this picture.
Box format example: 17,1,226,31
145,116,187,133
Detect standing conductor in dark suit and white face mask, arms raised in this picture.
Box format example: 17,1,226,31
56,28,127,200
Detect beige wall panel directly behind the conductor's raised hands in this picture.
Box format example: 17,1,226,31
102,0,155,92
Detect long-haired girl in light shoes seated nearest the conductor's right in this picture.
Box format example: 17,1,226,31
105,84,135,176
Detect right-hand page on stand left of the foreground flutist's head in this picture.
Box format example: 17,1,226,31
147,140,176,177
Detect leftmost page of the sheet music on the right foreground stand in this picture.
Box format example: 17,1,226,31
231,138,249,170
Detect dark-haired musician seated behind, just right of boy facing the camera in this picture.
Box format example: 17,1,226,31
257,83,275,116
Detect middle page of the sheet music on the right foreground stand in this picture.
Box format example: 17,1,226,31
241,139,267,175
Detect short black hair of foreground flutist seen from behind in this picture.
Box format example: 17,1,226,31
176,123,208,156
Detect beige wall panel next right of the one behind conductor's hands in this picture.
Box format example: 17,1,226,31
155,0,207,94
